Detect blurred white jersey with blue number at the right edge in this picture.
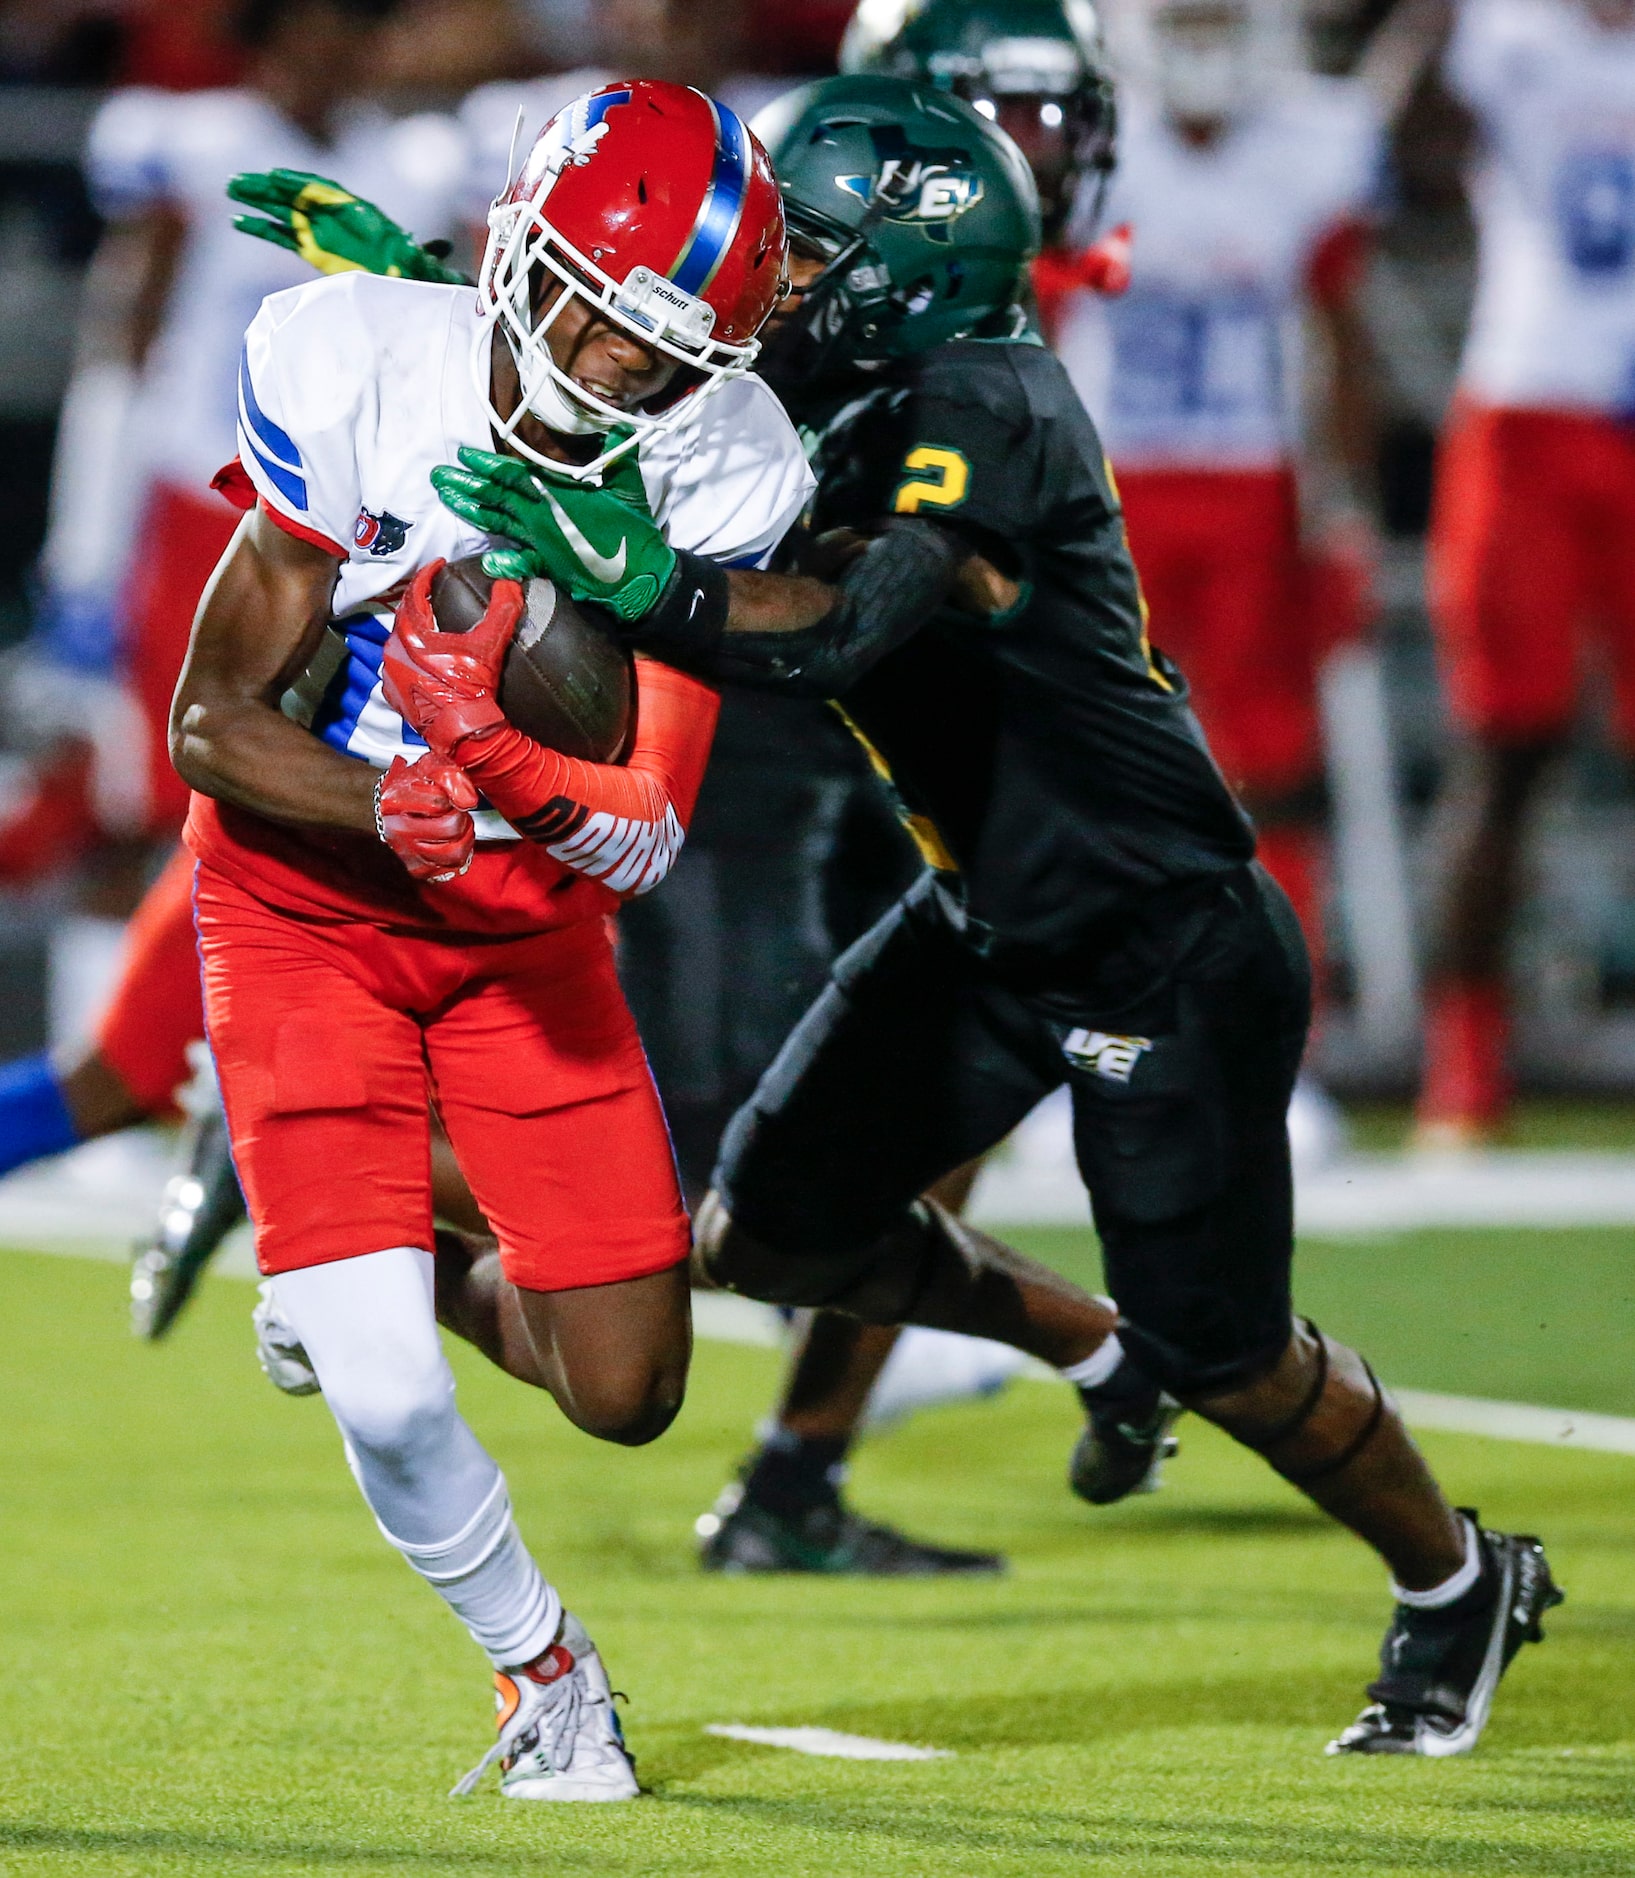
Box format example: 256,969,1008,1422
1447,0,1635,415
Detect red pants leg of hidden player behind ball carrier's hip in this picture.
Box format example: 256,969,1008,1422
96,847,205,1116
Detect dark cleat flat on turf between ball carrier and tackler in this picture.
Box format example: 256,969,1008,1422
695,1480,1004,1578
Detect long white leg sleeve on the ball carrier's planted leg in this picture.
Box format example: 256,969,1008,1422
274,1245,561,1668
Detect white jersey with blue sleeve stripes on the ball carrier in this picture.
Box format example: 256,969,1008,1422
238,274,815,777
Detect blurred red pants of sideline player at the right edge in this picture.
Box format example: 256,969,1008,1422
1430,400,1635,744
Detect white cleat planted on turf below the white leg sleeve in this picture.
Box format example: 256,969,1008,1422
459,1611,640,1799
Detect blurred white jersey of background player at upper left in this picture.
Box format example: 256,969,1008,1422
86,90,466,496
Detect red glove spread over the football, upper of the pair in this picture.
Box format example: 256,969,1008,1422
381,562,522,759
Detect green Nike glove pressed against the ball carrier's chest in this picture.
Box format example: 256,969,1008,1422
432,447,676,620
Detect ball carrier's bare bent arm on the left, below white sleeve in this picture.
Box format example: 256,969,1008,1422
171,509,375,834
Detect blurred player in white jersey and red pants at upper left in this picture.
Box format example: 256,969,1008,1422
4,0,462,864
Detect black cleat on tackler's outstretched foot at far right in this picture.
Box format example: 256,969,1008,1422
1327,1508,1564,1756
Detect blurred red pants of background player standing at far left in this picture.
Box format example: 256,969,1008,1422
126,483,240,834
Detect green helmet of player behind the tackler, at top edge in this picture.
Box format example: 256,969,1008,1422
841,0,1119,242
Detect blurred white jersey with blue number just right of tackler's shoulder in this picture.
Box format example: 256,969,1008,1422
1057,75,1382,470
